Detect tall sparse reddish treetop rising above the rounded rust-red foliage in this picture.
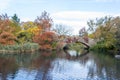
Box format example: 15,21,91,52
35,11,53,32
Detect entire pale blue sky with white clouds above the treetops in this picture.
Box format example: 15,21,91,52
0,0,120,34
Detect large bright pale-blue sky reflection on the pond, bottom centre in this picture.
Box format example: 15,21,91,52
49,59,88,80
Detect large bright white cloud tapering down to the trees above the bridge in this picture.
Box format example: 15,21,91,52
51,11,119,34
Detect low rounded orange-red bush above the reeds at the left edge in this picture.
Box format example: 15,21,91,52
0,32,16,45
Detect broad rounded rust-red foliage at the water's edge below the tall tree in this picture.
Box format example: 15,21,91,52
33,32,58,49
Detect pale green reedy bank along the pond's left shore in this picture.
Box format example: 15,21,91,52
0,43,39,53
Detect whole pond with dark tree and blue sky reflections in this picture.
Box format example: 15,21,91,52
0,51,120,80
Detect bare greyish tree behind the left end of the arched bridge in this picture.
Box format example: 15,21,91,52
53,24,72,35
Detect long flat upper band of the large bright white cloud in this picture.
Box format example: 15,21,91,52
52,11,110,21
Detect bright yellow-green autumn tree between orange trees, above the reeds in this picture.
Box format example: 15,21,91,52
17,21,41,43
